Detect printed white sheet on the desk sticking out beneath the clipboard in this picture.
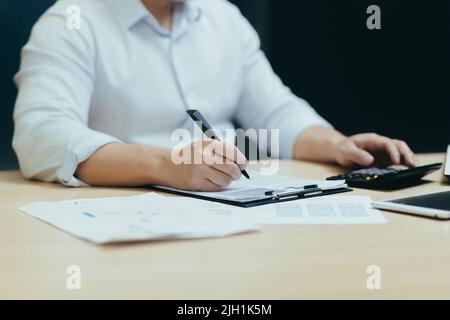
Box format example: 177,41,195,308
174,196,387,225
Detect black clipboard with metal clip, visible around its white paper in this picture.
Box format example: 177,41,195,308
149,186,353,208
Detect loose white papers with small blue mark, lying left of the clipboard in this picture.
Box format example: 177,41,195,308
19,193,258,244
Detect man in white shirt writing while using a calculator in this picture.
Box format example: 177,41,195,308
13,0,416,191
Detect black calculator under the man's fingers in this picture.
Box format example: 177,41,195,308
327,163,442,190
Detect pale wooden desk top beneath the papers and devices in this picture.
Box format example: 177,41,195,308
0,154,450,299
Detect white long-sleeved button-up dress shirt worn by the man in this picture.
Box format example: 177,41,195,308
13,0,329,186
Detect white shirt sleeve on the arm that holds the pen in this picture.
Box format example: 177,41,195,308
13,8,120,187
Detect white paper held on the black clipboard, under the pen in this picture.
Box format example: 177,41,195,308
158,171,347,202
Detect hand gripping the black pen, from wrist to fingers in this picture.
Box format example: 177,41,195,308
162,140,247,192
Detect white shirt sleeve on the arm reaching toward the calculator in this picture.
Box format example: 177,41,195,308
234,6,332,159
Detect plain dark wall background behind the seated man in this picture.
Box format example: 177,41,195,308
0,0,450,169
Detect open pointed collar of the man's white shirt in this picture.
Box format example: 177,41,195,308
116,0,202,29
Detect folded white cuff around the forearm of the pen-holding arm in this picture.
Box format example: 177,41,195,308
57,132,122,188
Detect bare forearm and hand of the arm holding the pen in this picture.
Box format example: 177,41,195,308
75,140,247,191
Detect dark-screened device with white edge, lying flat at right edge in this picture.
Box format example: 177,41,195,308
372,191,450,220
